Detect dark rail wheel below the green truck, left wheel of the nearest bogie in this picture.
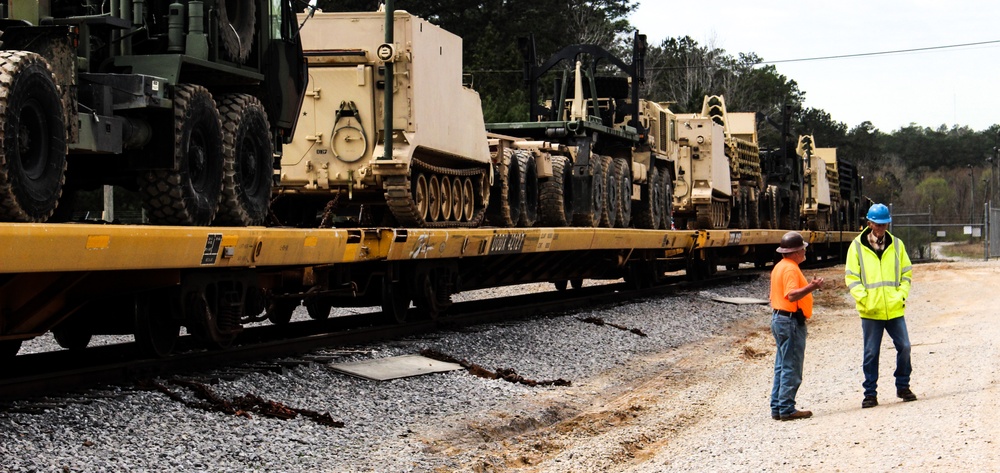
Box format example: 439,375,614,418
134,294,181,358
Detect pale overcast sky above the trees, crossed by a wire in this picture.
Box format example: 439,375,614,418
630,0,1000,132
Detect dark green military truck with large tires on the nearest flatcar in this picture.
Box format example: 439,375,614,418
0,0,305,226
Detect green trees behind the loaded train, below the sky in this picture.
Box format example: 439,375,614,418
308,0,1000,223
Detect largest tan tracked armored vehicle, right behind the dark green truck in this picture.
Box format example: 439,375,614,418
275,11,491,227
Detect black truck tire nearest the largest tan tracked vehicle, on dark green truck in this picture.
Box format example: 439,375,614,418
214,94,274,226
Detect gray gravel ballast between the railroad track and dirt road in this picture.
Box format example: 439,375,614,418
0,277,768,472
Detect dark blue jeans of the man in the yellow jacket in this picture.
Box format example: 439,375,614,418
861,317,913,396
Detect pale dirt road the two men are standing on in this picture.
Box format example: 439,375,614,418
425,261,1000,472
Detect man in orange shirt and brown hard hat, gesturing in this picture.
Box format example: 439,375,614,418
771,232,823,420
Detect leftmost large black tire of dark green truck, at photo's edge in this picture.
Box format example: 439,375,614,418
0,51,66,222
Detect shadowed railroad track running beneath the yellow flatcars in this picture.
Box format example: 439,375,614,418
0,270,761,402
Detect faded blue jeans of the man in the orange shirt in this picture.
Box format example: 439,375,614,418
771,313,807,416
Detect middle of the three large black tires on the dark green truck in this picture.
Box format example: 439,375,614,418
139,84,224,226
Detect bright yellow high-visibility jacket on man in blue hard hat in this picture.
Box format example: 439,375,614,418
844,229,913,320
